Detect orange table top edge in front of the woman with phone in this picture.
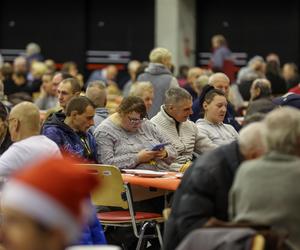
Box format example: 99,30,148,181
122,173,181,191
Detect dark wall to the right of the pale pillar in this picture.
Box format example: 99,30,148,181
197,0,300,64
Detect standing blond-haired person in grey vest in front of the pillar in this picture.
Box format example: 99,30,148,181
137,48,179,118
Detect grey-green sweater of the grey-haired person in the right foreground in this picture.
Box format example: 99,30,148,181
229,152,300,249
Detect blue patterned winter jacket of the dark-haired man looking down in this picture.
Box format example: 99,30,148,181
42,111,97,163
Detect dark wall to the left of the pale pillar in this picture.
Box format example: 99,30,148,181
0,0,154,76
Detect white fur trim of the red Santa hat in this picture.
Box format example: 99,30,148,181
1,180,80,242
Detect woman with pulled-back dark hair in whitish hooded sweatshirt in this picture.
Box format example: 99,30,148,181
196,89,238,146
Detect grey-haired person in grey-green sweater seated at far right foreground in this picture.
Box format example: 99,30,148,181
230,107,300,249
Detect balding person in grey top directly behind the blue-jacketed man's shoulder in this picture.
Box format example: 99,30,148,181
85,81,108,132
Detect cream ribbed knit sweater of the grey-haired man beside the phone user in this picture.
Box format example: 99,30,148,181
151,105,216,171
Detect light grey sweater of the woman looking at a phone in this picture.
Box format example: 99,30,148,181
94,118,177,170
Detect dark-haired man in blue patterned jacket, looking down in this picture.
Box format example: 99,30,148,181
42,96,97,162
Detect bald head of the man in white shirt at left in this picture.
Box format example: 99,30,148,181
10,102,40,133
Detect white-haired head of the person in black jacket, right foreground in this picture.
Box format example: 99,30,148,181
238,122,267,159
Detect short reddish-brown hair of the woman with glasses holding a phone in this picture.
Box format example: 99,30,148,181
117,96,147,118
